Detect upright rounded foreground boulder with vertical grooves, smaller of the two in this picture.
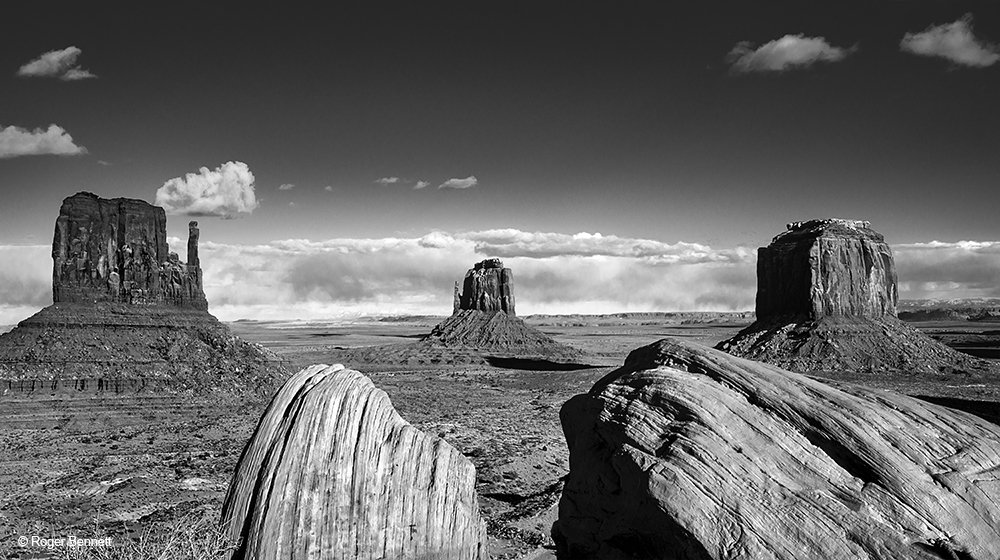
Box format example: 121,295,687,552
223,364,486,560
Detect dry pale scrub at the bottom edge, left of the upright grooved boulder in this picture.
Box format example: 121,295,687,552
44,508,236,560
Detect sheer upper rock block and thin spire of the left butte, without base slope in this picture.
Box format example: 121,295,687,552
52,192,208,309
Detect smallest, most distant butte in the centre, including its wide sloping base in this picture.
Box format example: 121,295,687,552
328,259,584,369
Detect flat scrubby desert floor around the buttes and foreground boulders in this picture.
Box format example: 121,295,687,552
0,314,1000,558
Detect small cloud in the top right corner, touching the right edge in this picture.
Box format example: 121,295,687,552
899,14,1000,68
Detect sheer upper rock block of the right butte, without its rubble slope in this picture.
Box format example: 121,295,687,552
757,218,898,319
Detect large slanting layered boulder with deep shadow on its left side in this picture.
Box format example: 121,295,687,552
554,339,1000,560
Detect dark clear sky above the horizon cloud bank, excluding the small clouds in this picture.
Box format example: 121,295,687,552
0,1,1000,247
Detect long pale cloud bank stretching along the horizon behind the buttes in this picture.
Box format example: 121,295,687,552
0,229,1000,324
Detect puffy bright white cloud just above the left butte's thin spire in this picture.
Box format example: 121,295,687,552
156,161,258,219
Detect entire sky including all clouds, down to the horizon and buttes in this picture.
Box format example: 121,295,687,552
0,0,1000,323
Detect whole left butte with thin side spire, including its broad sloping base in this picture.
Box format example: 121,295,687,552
0,192,285,397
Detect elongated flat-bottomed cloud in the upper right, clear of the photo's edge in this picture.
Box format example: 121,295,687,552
726,35,854,73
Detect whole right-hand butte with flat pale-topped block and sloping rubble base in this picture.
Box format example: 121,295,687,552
716,218,993,375
